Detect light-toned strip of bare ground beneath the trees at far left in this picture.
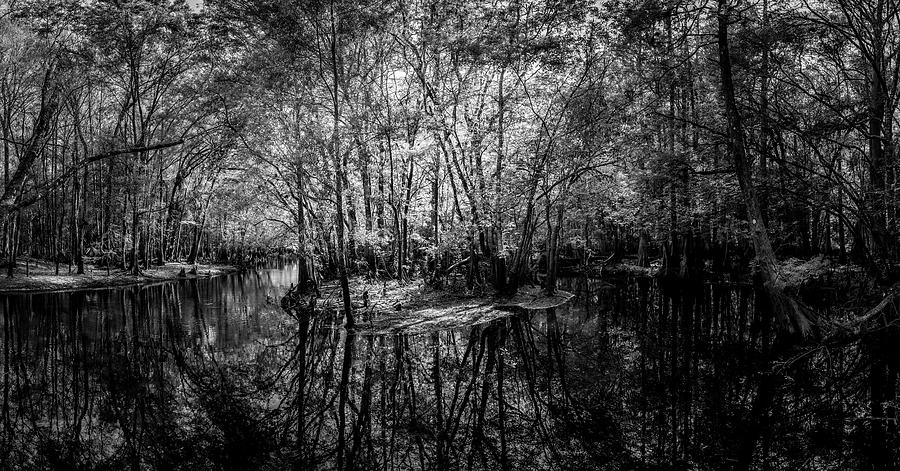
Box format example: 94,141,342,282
0,259,238,293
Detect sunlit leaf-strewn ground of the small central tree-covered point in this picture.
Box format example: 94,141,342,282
283,278,575,334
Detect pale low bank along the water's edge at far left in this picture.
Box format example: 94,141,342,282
0,262,240,295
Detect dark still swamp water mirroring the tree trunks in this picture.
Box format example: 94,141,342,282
0,266,900,470
